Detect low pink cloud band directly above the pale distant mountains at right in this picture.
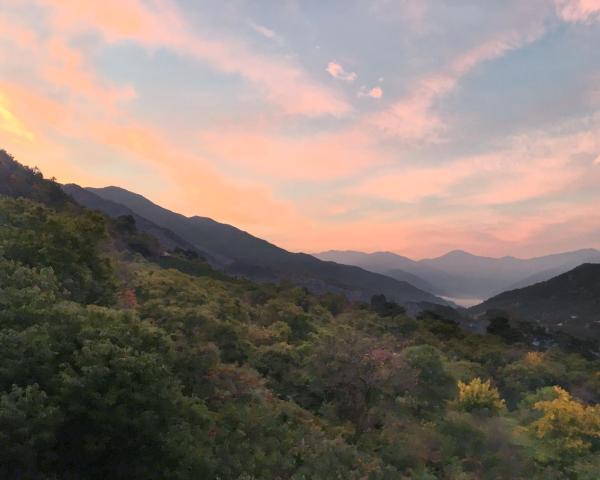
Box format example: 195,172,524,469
284,186,600,258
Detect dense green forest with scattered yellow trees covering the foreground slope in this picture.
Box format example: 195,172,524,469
0,151,600,480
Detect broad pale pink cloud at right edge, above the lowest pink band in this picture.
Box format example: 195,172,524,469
348,117,600,206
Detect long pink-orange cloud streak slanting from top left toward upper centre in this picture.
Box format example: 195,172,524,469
31,0,351,117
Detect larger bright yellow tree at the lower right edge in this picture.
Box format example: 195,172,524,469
530,387,600,462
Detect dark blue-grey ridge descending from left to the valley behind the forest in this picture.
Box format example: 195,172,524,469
71,186,448,305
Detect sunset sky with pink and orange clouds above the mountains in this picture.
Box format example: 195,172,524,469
0,0,600,258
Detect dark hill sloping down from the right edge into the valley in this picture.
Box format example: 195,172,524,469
469,263,600,339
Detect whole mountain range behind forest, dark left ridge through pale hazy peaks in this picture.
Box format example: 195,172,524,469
63,185,600,311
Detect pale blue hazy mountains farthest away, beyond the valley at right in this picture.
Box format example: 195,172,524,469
315,249,600,300
